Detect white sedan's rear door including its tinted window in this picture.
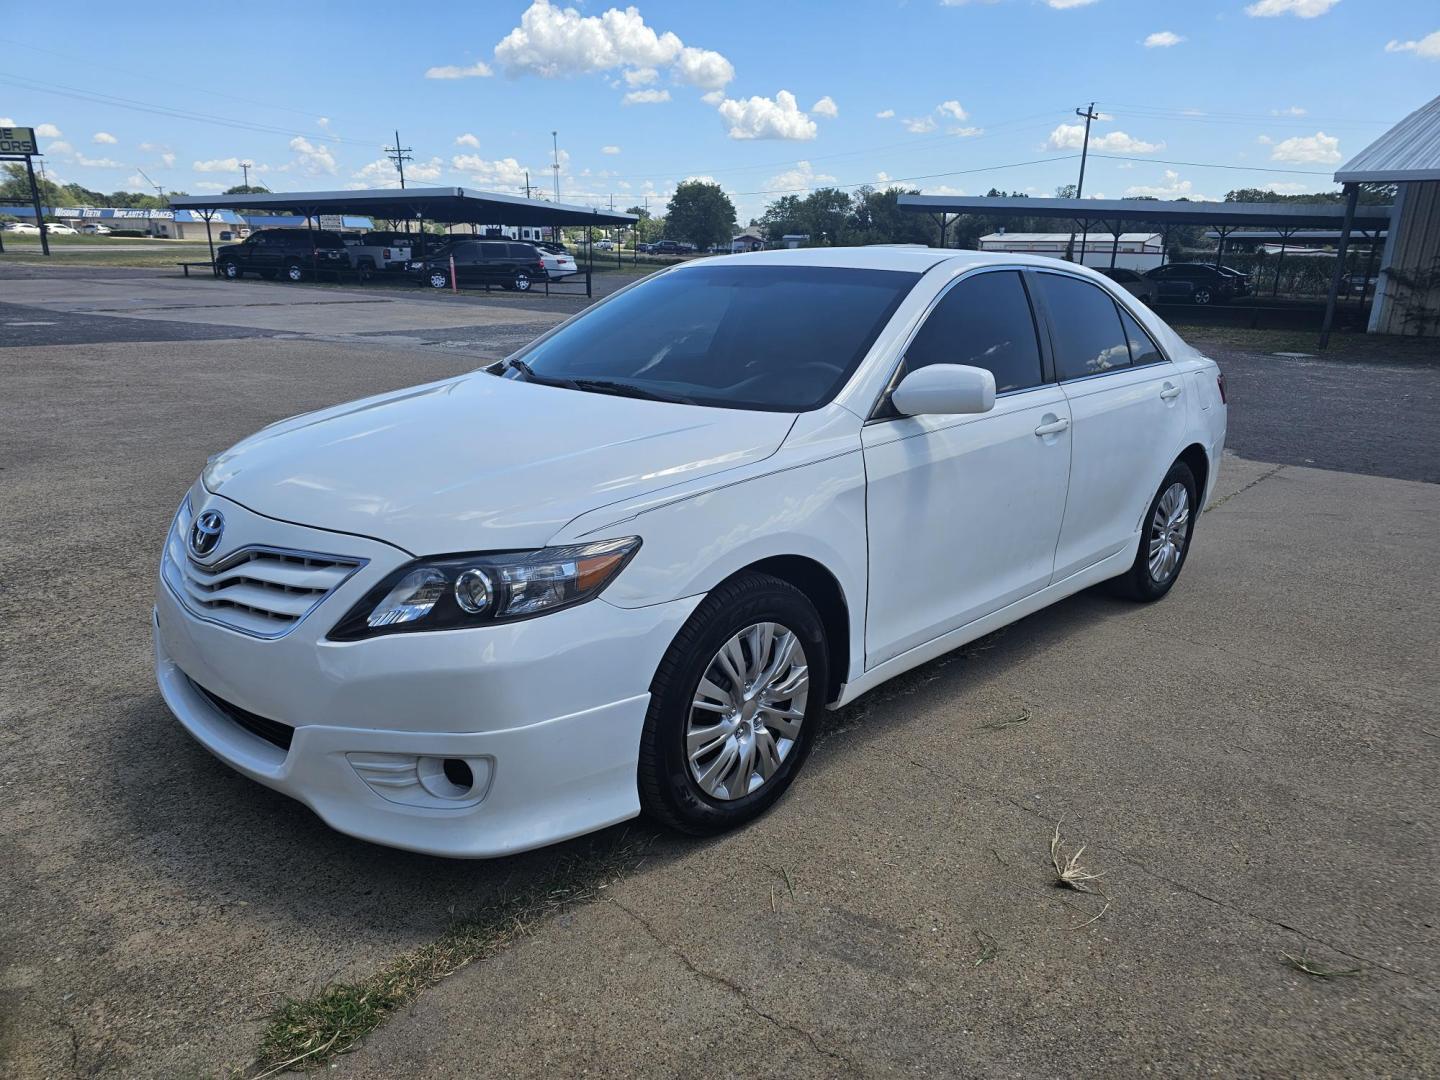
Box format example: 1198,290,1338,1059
1034,271,1185,580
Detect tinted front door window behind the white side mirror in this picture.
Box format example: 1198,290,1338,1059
904,271,1043,393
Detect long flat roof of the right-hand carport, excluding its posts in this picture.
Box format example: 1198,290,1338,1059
899,194,1391,229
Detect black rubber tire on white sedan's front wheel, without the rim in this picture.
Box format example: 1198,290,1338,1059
638,573,829,835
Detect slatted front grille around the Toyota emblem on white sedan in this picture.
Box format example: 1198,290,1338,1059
161,500,366,638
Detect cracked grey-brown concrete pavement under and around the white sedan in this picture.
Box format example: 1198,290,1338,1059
0,266,1440,1077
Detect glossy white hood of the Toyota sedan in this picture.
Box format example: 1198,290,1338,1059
204,372,795,554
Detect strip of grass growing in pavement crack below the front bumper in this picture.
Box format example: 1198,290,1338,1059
252,835,648,1080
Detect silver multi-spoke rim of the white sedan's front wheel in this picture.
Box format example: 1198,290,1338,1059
685,622,809,802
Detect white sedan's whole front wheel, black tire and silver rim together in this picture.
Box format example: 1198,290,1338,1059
638,573,829,835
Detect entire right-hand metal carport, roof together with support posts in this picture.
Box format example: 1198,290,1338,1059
899,194,1394,347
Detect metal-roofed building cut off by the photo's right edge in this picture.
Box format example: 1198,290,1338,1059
1335,98,1440,336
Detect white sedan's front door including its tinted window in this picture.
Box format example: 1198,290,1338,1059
863,269,1070,668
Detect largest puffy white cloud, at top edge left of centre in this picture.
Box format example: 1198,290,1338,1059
495,0,734,91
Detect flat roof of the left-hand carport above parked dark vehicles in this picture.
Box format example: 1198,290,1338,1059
170,187,635,225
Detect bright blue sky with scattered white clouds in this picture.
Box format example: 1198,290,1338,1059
0,0,1440,222
